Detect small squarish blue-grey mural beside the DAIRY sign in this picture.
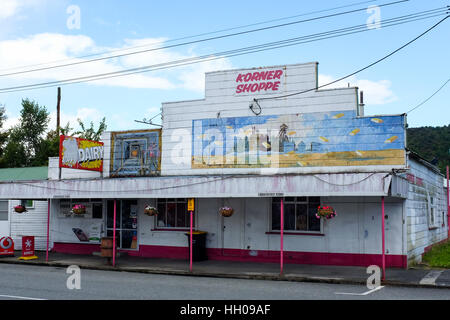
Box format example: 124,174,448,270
110,129,161,177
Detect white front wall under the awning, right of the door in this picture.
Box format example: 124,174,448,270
139,197,406,255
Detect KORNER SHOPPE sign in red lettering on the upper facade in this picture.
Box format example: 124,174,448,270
235,68,285,95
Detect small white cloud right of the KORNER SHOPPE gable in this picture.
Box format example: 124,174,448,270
319,74,397,105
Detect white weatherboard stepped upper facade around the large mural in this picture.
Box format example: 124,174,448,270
161,62,360,175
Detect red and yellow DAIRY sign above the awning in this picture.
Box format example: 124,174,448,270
59,136,104,172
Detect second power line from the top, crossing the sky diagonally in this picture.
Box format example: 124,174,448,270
0,0,408,77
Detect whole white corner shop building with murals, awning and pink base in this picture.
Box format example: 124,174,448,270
0,63,449,267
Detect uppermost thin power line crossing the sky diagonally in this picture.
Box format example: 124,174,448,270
0,0,382,72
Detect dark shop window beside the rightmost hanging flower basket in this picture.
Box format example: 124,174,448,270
271,197,321,232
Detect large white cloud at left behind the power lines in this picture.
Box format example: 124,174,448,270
0,33,231,91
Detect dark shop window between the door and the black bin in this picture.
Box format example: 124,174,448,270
156,199,190,229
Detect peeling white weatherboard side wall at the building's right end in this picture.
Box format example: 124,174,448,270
406,159,448,263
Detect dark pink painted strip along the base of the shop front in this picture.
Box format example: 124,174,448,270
52,243,408,268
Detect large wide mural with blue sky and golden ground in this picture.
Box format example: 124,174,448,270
191,111,405,169
